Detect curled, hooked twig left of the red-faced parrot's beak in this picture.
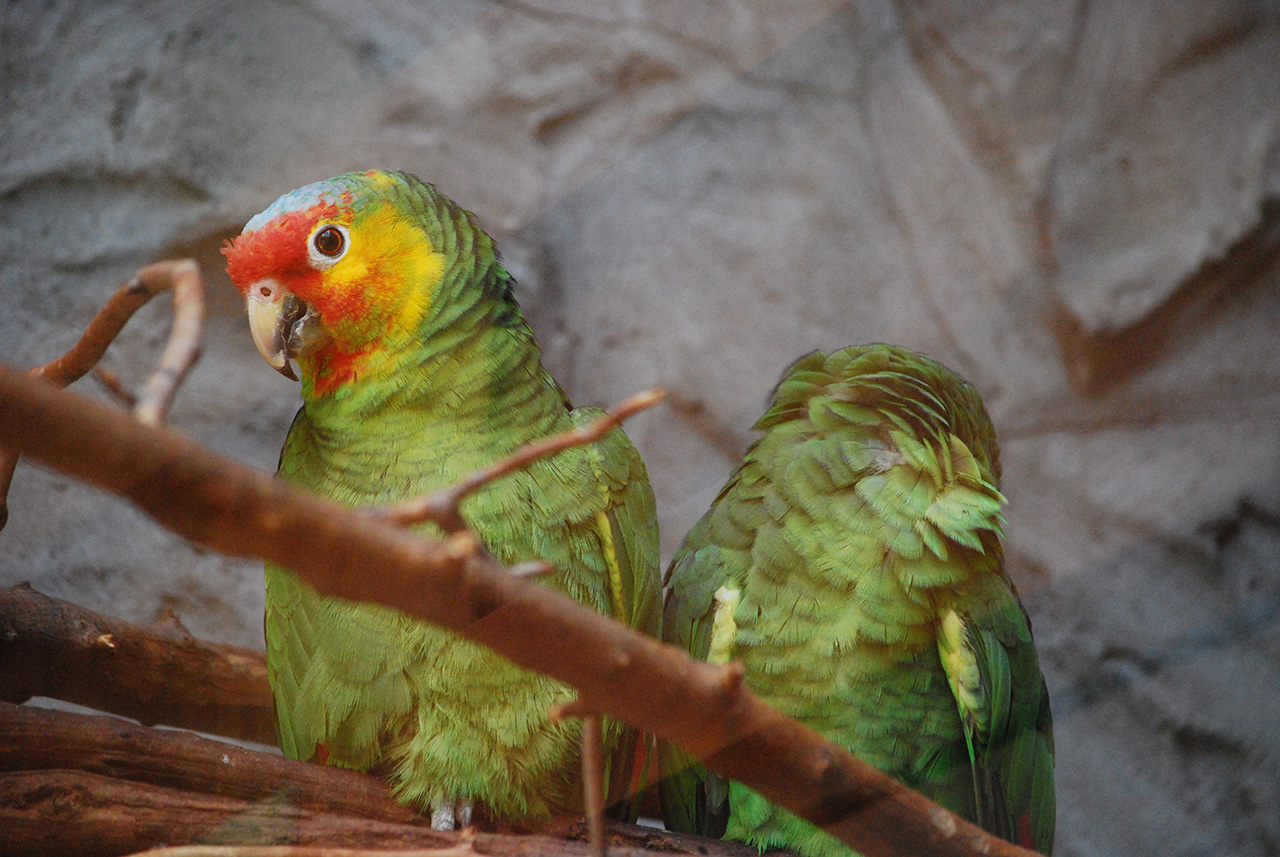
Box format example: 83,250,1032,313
0,258,205,530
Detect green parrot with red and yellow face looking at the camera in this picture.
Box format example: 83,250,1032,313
223,170,662,829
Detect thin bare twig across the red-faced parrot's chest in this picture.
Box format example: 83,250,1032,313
369,388,667,532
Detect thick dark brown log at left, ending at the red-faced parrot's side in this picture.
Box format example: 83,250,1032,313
0,586,275,744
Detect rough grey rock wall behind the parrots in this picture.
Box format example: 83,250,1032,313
0,0,1280,854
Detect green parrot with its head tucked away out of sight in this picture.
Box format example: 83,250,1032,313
659,345,1055,857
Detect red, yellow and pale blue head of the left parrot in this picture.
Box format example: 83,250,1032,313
223,170,494,393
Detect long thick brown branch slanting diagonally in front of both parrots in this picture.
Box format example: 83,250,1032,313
0,367,1032,857
